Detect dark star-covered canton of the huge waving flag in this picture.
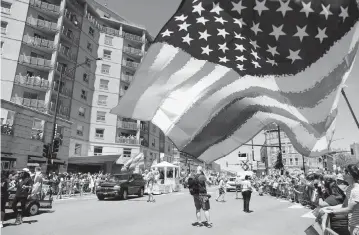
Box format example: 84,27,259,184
159,0,353,73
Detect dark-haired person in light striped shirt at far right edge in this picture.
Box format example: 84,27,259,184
326,164,359,235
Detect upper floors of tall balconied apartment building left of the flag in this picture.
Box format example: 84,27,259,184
1,0,173,171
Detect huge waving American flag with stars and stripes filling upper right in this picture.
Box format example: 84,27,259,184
112,0,359,162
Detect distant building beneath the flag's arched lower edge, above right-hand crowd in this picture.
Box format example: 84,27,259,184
260,124,323,173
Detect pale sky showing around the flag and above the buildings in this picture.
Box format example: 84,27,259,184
97,0,359,171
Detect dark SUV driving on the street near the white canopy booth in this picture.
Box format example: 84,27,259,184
96,173,146,200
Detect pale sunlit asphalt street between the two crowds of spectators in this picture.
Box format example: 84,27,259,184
1,188,314,235
